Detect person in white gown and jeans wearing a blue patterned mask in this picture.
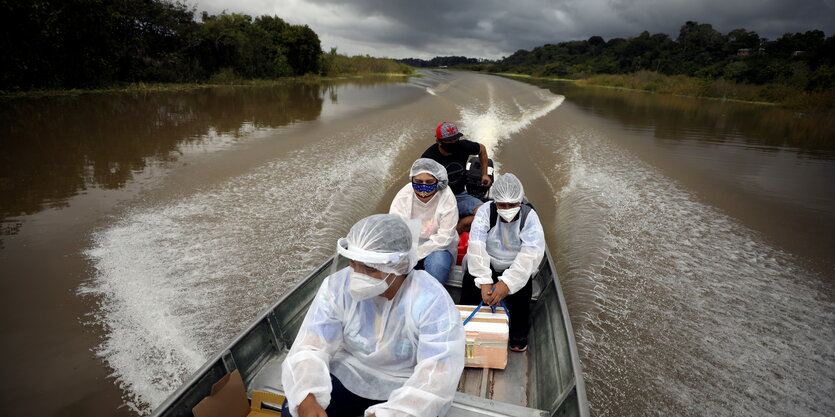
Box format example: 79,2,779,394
389,158,458,284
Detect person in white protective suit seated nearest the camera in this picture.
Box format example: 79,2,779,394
281,214,465,417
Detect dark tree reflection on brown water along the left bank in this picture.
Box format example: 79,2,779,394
0,78,406,232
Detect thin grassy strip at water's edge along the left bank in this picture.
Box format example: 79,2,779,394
0,73,418,100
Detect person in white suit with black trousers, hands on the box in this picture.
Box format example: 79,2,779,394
461,174,545,352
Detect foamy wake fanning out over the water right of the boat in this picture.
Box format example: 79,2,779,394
550,131,835,416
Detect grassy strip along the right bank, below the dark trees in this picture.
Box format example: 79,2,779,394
497,71,835,112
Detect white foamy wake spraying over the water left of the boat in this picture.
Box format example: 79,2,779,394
80,123,419,414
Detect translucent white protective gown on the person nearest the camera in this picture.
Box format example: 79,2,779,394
281,268,465,417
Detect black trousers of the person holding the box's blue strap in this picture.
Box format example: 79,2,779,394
461,265,533,341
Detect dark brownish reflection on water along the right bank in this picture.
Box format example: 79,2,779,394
526,80,835,158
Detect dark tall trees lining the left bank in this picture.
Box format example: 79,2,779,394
0,0,326,91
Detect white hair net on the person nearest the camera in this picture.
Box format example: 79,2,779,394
336,214,417,275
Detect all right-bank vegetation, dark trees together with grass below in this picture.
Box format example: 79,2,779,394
408,22,835,109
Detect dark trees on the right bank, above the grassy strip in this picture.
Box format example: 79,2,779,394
403,21,835,91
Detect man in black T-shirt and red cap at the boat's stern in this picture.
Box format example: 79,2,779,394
421,122,492,233
